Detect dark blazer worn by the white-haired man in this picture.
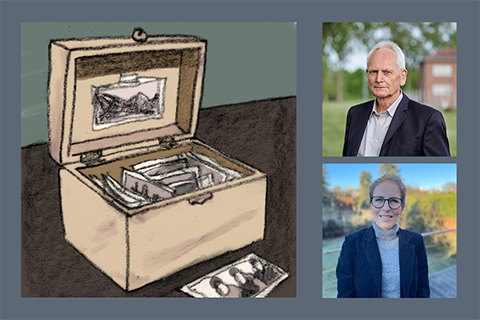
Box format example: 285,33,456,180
343,94,450,157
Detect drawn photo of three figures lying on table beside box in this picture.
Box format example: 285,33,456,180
181,253,289,298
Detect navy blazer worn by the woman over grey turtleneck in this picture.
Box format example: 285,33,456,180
337,227,430,298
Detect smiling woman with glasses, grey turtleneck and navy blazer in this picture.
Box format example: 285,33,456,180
337,174,430,298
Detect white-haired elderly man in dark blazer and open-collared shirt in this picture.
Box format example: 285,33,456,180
343,41,450,157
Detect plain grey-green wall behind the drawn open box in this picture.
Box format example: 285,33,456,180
21,23,296,146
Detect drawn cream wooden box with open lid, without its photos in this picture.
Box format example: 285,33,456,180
48,32,266,290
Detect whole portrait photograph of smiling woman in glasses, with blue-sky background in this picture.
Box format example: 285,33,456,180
322,163,457,298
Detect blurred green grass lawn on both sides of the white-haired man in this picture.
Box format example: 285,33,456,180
322,100,457,157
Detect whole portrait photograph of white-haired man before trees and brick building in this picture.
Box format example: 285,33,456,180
322,22,457,157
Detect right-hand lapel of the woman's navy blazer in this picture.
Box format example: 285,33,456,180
398,229,415,298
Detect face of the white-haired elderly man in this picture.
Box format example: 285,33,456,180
367,48,407,103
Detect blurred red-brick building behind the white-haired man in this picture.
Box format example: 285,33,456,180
420,47,457,110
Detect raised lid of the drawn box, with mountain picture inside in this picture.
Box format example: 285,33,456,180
48,29,207,164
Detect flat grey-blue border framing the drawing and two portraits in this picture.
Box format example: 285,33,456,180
0,0,480,319
